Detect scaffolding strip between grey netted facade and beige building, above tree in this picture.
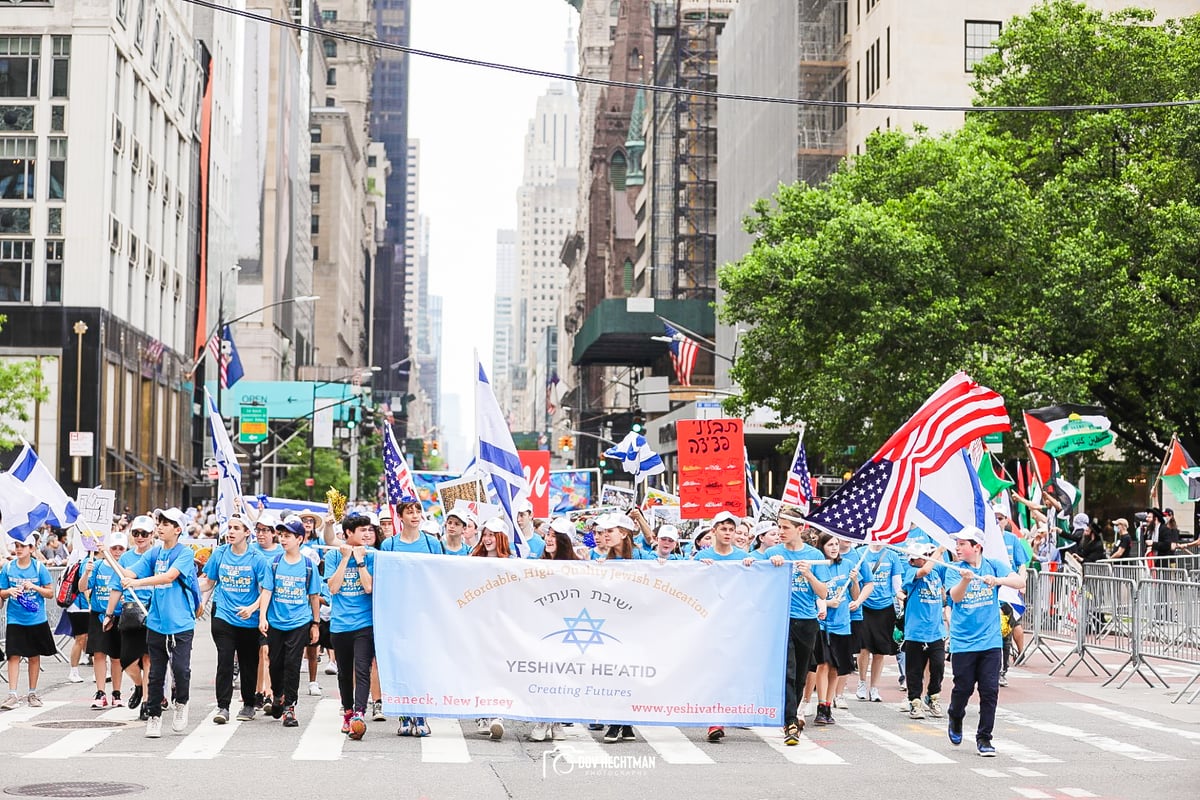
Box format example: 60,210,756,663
796,0,850,185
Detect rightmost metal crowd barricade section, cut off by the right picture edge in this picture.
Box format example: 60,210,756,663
1122,581,1200,703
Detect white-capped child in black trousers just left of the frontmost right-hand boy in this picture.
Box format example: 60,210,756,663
900,543,946,720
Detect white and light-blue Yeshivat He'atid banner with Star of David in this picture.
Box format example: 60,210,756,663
373,553,791,726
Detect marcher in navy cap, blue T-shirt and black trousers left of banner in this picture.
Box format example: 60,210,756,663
258,519,320,728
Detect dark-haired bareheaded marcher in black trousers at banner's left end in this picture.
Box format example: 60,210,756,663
325,515,372,741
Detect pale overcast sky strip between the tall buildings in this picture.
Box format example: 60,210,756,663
408,0,578,468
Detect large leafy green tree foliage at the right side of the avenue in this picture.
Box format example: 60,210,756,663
721,0,1200,465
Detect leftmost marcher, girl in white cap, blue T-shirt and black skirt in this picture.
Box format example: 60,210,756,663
0,541,58,711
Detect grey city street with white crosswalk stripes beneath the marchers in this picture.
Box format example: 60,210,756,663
0,626,1200,800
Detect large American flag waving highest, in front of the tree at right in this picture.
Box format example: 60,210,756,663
806,372,1010,543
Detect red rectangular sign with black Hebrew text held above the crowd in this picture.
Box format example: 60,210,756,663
676,420,746,519
